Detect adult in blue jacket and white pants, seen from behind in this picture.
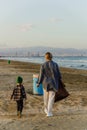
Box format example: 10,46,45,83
37,52,61,117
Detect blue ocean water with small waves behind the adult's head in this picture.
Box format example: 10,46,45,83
0,56,87,70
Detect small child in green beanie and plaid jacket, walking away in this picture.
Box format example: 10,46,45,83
11,76,26,118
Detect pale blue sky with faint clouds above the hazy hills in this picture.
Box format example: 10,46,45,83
0,0,87,49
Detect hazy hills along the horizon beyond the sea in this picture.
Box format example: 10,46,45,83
0,46,87,57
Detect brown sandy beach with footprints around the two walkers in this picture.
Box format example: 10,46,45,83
0,60,87,130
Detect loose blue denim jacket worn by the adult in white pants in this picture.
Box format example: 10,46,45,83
38,61,61,91
